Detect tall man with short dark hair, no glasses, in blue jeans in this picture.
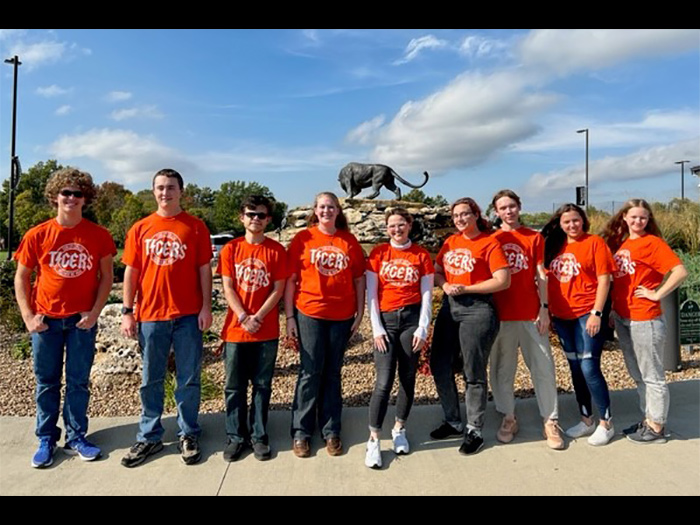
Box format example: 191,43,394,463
122,169,212,468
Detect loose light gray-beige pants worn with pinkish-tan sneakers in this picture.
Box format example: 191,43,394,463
491,321,559,419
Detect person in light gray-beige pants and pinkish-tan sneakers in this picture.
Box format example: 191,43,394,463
490,190,564,450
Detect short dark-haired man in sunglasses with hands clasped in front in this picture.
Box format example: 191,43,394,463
216,195,287,462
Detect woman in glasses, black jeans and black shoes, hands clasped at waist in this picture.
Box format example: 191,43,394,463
430,197,510,456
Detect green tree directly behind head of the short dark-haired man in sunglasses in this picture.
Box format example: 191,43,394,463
212,181,287,235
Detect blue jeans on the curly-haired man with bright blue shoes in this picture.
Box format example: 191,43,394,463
32,314,97,442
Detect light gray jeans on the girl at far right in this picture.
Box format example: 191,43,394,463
615,315,671,425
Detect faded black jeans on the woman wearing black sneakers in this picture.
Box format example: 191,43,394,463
430,294,500,430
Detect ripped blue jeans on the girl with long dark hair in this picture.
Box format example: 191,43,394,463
553,314,612,421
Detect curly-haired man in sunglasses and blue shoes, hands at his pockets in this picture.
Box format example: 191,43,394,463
14,168,117,468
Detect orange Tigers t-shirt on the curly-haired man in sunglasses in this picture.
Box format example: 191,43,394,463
14,219,117,319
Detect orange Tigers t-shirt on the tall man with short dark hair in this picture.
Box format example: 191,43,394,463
122,211,212,322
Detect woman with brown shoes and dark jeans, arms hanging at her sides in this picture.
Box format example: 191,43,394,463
284,192,365,458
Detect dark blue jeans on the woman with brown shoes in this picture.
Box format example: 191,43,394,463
292,310,355,440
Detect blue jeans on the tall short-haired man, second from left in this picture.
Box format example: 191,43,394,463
137,315,203,443
